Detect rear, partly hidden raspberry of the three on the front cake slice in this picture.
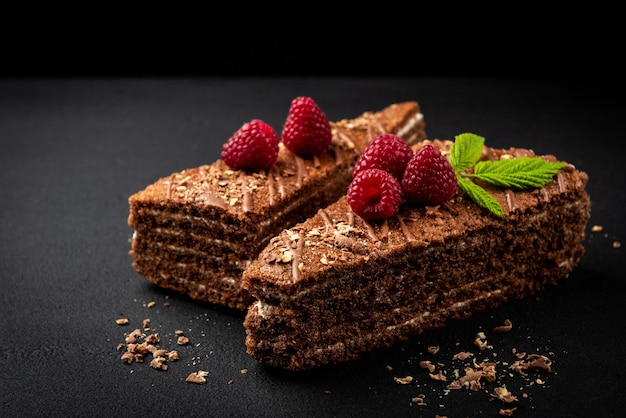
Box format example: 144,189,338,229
352,134,413,181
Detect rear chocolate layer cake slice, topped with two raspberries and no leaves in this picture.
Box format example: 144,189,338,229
128,102,425,310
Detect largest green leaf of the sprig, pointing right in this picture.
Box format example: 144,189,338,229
466,157,565,190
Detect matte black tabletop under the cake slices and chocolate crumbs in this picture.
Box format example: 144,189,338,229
0,78,626,417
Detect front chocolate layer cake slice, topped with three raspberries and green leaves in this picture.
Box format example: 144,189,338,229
243,140,590,371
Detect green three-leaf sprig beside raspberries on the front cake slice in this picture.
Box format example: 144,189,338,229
450,133,565,218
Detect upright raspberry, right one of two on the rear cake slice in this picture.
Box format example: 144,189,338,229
282,96,332,158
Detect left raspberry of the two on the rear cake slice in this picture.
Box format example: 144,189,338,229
222,119,280,171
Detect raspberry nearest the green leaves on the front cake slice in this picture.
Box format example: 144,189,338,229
402,144,457,206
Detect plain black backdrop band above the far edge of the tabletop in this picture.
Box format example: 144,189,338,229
0,7,624,79
